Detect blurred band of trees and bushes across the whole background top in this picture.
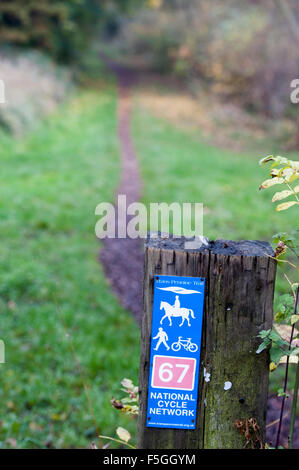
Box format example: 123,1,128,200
0,0,299,144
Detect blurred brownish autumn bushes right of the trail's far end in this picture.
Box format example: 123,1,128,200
114,0,299,117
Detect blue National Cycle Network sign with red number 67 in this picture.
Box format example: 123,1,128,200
147,275,205,429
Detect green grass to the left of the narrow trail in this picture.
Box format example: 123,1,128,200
0,87,139,448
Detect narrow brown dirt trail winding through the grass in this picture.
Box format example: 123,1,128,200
100,54,143,324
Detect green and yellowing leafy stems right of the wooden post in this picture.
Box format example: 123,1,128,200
256,155,299,448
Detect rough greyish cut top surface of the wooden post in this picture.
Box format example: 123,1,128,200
145,233,274,256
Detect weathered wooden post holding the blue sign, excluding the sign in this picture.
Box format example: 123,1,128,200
138,236,276,449
